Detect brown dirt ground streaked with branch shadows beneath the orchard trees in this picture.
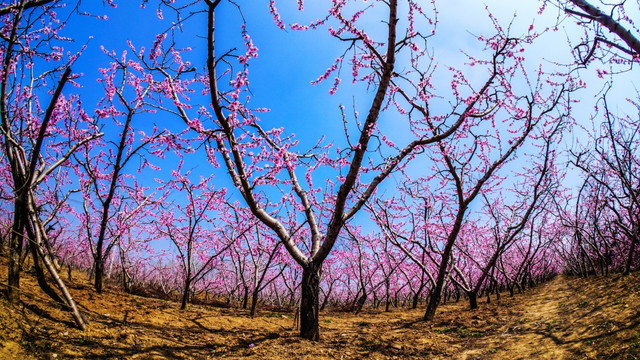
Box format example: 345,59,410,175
0,260,640,360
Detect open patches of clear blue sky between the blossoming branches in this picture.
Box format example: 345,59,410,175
51,0,633,236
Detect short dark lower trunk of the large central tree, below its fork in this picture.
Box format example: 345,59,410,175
300,263,322,341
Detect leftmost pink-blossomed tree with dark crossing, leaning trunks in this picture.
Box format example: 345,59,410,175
0,1,102,329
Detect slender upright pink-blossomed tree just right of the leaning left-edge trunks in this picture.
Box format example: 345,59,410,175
74,46,171,293
